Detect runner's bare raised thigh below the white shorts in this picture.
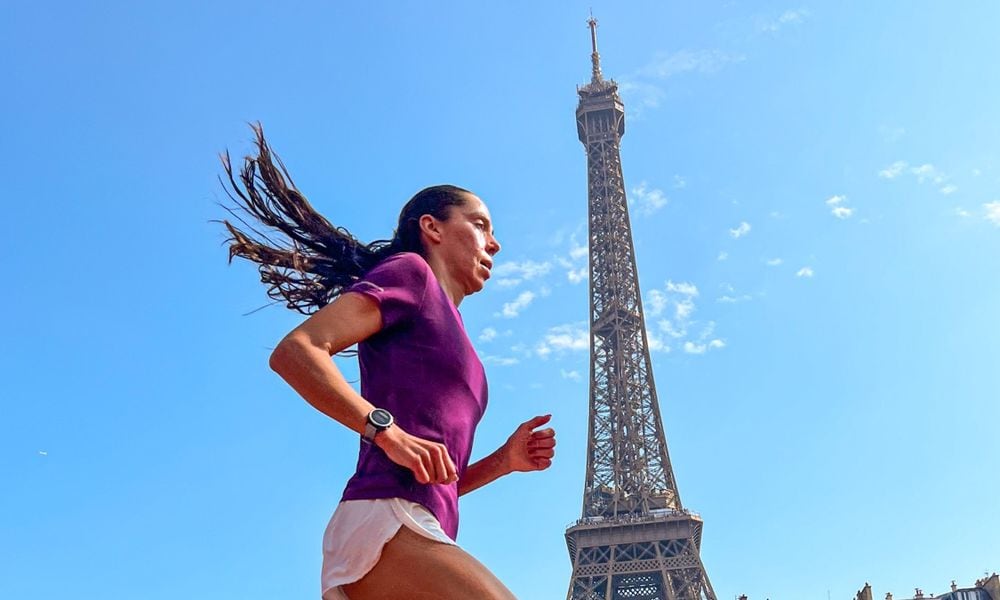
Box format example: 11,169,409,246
343,526,514,600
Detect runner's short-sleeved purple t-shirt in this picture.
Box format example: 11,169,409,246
343,252,487,539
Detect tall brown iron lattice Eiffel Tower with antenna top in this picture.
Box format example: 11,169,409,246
566,18,716,600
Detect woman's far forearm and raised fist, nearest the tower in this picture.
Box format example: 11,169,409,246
458,415,556,496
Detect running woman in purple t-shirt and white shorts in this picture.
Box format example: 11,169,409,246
223,125,555,600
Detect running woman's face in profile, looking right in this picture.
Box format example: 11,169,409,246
435,194,500,296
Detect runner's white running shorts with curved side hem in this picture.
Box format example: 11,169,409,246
321,498,457,600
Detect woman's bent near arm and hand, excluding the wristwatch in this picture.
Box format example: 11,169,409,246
270,293,457,483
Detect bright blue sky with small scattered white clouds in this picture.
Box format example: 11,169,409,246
0,1,1000,600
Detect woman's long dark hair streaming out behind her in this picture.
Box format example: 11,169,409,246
220,123,470,315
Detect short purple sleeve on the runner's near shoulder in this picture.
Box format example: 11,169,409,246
344,252,432,329
